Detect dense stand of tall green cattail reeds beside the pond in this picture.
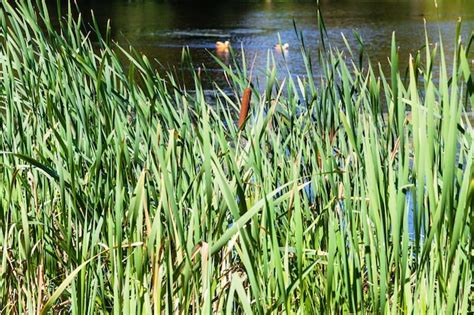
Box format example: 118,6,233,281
0,0,474,314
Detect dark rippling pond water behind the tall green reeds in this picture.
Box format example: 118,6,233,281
57,0,474,81
